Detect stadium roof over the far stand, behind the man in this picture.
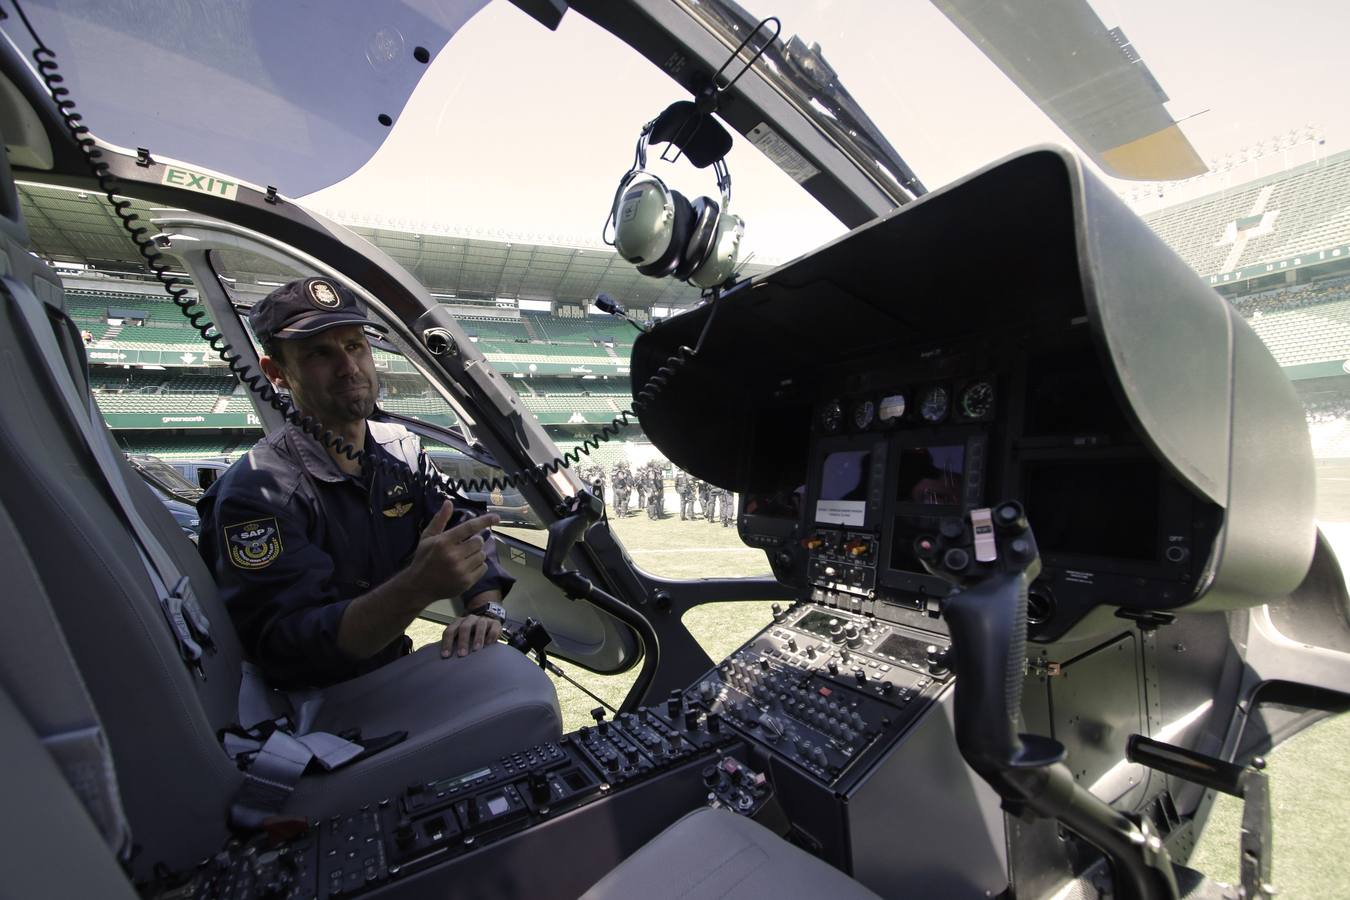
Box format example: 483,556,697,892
19,182,768,309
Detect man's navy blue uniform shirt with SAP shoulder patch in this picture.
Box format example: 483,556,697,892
197,421,514,688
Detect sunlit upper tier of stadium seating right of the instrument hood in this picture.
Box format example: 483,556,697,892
1143,150,1350,285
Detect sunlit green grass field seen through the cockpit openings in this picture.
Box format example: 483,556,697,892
409,483,1350,900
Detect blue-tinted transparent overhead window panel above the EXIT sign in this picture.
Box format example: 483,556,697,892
4,0,486,196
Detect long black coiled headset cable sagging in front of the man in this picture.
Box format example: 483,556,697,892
12,0,721,497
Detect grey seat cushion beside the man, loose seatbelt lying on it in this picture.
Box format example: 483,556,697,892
286,644,563,816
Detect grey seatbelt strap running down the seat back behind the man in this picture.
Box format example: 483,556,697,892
3,277,215,679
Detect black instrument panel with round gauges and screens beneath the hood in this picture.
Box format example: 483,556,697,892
740,330,1218,640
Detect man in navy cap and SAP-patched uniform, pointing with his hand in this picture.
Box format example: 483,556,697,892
198,278,513,688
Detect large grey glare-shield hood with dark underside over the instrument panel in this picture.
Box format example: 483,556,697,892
632,148,1315,604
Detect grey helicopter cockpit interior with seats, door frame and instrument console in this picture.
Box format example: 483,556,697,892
0,0,1350,900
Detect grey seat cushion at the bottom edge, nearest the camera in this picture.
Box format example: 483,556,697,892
582,808,878,900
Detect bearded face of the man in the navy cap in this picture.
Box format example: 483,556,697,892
263,325,379,428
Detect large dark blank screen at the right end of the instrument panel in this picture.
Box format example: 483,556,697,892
1022,459,1160,560
